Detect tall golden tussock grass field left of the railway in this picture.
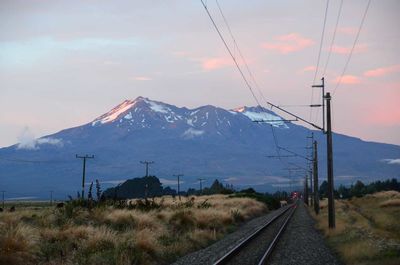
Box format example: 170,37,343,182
0,195,267,265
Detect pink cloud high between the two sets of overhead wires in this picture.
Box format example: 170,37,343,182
262,33,314,54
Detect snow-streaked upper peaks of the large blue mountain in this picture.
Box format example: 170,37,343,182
92,97,288,129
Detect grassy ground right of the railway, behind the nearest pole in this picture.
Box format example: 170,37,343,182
310,191,400,265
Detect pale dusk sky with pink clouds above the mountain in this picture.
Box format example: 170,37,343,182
0,0,400,147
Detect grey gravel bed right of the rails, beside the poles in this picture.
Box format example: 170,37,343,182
268,203,341,265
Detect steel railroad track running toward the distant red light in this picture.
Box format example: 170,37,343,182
213,203,297,265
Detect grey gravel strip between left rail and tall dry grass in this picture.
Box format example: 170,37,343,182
173,207,286,265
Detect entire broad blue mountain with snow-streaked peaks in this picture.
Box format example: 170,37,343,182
0,97,400,197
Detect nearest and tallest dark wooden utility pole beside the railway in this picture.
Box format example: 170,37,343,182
325,92,336,228
